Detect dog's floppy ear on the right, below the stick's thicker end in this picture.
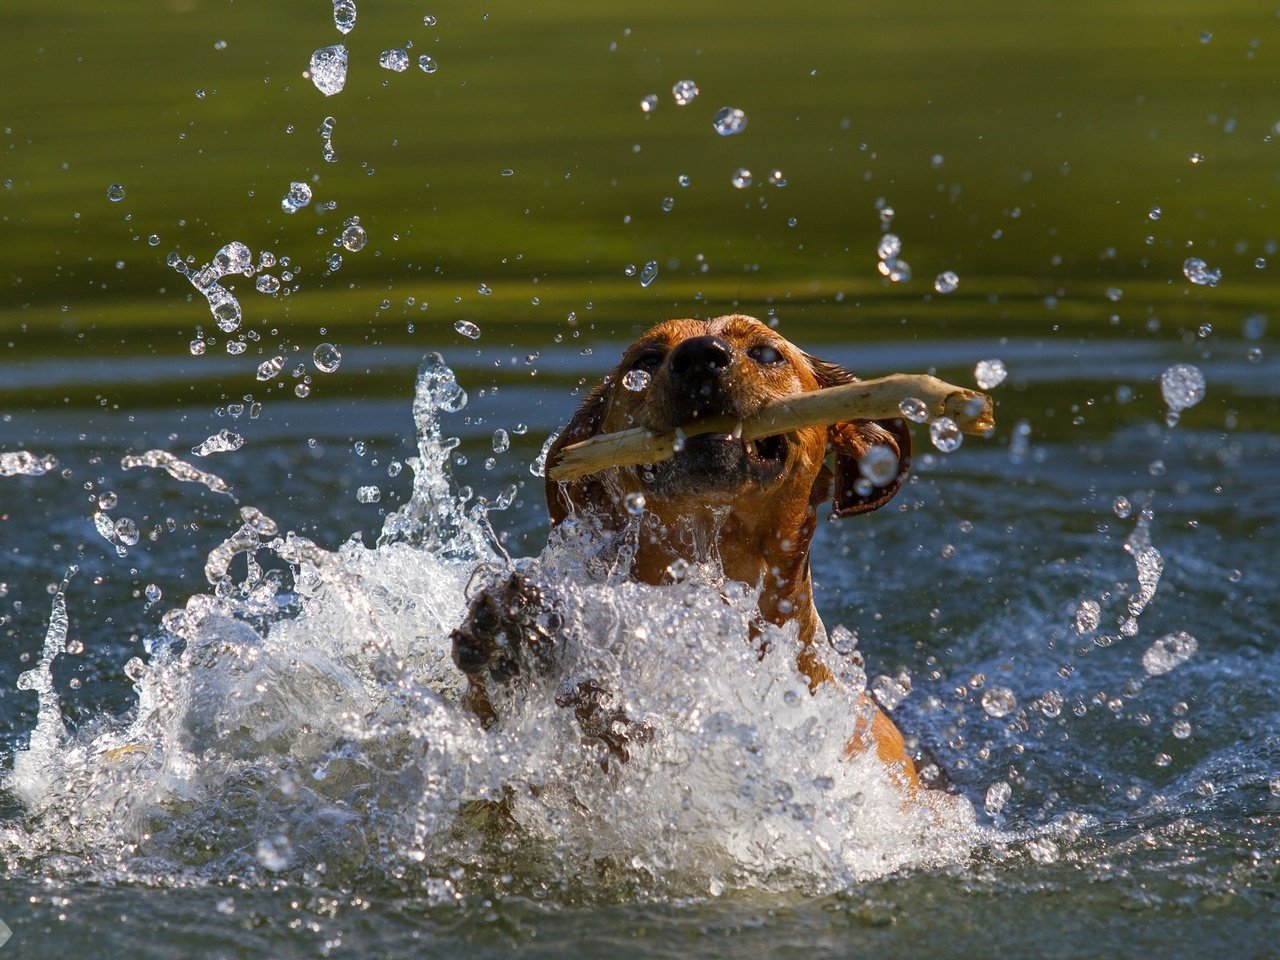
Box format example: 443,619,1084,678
806,356,911,517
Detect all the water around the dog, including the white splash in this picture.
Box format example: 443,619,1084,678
0,0,1280,957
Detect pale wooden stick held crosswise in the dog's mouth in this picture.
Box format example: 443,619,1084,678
547,374,996,480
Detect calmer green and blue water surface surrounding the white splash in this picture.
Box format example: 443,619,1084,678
0,3,1280,957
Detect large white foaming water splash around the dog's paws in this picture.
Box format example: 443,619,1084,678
0,355,979,902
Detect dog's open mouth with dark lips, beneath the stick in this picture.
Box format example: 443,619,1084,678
640,433,787,493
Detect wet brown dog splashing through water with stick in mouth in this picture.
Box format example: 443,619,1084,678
453,315,918,788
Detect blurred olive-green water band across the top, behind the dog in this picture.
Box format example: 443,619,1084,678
0,0,1280,355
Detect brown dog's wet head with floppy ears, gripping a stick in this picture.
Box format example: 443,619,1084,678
547,315,911,537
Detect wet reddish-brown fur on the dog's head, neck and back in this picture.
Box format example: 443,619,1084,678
547,315,918,788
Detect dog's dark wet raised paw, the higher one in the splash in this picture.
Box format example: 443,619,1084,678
449,573,563,684
